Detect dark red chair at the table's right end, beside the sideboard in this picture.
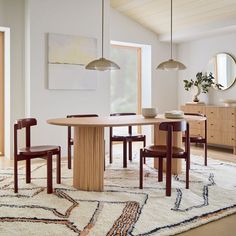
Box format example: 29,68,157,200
182,113,207,166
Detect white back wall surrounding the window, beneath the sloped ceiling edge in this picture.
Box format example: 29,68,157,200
110,8,178,112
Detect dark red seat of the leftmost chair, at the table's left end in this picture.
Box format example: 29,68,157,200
19,145,60,156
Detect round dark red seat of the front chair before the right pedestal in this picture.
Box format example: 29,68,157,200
144,145,185,158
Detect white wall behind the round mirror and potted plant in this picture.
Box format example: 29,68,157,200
178,32,236,105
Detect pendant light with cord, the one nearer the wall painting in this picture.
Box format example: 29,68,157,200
85,0,120,71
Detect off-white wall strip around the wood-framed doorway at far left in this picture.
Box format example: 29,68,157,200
0,0,25,158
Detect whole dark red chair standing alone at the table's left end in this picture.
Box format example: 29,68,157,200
14,118,61,193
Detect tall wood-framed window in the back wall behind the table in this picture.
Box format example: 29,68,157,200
110,44,141,114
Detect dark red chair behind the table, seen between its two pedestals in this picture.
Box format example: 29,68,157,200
110,113,146,168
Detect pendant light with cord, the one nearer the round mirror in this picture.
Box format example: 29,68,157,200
156,0,186,71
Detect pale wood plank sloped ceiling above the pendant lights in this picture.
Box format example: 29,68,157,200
110,0,236,41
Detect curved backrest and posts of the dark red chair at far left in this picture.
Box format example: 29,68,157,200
14,118,37,155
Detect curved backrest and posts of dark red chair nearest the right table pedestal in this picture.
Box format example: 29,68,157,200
159,120,190,155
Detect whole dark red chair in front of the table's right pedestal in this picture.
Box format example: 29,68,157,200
139,121,190,196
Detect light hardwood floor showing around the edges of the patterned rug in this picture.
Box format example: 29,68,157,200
0,145,236,236
